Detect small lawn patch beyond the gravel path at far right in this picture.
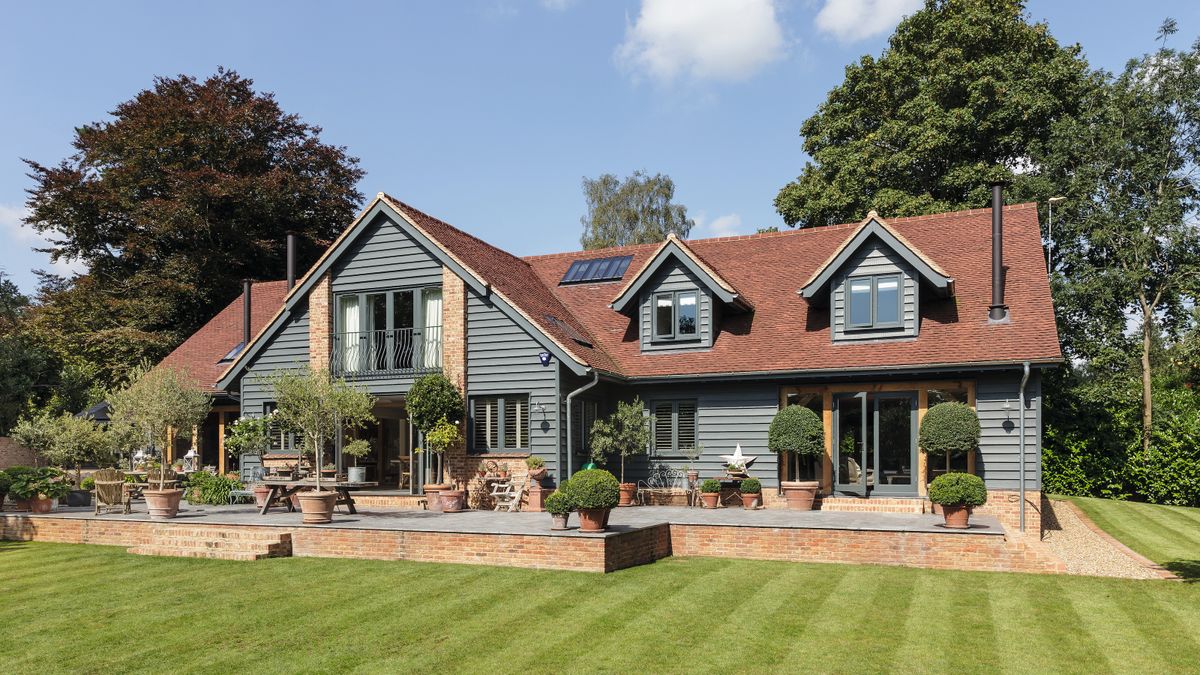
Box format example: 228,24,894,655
1068,497,1200,581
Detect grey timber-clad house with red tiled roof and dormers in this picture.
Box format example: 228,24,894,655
172,187,1062,527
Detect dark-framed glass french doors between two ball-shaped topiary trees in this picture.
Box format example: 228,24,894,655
834,392,917,497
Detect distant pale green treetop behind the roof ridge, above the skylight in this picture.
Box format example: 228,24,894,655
580,171,696,250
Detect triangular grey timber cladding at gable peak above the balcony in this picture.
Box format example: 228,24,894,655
332,216,442,294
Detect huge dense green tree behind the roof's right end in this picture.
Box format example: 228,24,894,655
775,0,1094,227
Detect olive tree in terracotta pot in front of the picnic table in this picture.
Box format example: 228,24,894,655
270,366,374,524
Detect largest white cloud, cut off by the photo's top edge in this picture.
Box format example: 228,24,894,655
616,0,785,83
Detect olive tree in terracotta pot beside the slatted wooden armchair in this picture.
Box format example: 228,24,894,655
108,365,212,519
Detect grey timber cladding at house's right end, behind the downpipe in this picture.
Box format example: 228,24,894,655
976,371,1042,490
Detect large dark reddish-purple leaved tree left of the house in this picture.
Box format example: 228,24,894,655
25,70,362,384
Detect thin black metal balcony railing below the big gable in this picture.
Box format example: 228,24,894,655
329,325,442,376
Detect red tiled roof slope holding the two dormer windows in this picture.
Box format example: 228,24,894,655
524,199,1062,377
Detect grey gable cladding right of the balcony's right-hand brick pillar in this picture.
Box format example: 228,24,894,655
467,289,560,476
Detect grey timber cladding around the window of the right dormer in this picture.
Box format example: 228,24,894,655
830,237,920,341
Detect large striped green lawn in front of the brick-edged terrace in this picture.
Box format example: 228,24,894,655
7,543,1200,674
